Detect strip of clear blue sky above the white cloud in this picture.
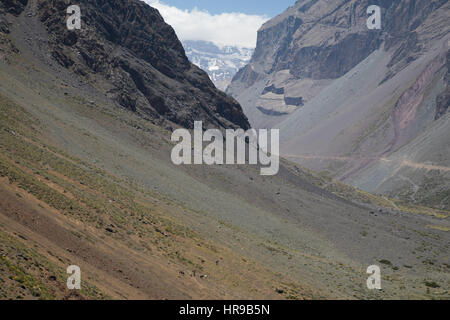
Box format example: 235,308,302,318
155,0,295,17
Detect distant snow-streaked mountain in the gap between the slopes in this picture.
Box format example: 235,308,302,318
183,40,254,91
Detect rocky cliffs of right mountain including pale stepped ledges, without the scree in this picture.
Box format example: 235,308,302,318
228,0,448,126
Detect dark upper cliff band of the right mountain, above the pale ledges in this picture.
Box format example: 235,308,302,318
230,0,447,87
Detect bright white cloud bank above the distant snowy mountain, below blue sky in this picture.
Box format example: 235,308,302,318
144,0,269,48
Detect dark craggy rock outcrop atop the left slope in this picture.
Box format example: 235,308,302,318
34,0,249,128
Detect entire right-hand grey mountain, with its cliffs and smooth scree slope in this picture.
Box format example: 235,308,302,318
228,0,450,208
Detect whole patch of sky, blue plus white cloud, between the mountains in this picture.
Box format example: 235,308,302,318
143,0,295,48
